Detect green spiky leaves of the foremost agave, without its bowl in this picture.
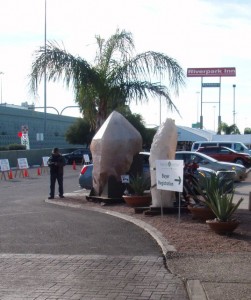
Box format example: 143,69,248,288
196,175,243,222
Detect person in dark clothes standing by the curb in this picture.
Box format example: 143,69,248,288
48,148,66,199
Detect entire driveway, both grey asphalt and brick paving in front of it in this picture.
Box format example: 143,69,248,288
0,166,188,300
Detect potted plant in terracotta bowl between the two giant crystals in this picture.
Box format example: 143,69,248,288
123,174,152,207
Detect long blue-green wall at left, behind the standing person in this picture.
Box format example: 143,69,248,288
0,104,81,149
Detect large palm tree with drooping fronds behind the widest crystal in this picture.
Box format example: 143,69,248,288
30,29,185,130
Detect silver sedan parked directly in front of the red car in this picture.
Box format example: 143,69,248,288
175,151,247,181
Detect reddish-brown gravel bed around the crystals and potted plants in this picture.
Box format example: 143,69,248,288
59,196,251,253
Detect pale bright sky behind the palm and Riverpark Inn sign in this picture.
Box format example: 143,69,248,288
0,0,251,133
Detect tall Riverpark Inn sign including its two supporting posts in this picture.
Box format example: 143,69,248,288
187,67,236,129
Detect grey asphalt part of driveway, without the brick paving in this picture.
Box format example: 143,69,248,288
0,166,161,255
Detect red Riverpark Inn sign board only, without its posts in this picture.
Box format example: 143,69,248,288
187,68,236,77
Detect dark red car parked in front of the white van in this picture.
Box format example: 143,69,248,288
196,146,251,167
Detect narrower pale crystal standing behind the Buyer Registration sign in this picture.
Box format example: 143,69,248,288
149,119,177,207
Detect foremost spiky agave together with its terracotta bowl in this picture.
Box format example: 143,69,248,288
194,175,243,234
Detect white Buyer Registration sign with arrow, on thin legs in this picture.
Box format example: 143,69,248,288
156,160,184,221
